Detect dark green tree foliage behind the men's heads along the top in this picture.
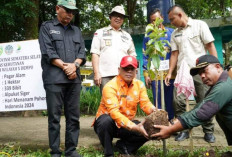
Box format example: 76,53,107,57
0,0,232,43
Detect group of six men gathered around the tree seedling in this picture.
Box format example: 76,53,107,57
39,0,232,157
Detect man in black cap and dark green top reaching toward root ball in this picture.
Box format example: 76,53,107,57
153,55,232,145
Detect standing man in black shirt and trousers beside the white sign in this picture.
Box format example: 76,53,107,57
39,0,86,157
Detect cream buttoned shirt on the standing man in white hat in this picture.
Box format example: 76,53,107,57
90,26,136,77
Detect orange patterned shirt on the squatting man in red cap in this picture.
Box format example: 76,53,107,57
93,75,155,129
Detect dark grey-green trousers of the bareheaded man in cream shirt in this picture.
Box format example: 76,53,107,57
173,75,214,133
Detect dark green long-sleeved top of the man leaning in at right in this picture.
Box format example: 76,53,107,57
178,71,232,132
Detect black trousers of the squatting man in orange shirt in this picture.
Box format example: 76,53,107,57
94,114,148,156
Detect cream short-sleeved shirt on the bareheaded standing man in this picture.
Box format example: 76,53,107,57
171,18,214,69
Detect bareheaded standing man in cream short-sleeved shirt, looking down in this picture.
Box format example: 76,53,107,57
165,5,217,143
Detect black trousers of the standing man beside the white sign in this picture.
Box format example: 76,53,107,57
44,83,81,155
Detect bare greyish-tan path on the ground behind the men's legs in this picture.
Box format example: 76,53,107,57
0,116,227,149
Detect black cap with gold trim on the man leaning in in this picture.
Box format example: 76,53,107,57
190,55,220,76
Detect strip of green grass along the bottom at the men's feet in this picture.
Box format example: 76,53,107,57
0,145,231,157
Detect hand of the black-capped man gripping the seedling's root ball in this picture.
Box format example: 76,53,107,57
151,125,171,140
